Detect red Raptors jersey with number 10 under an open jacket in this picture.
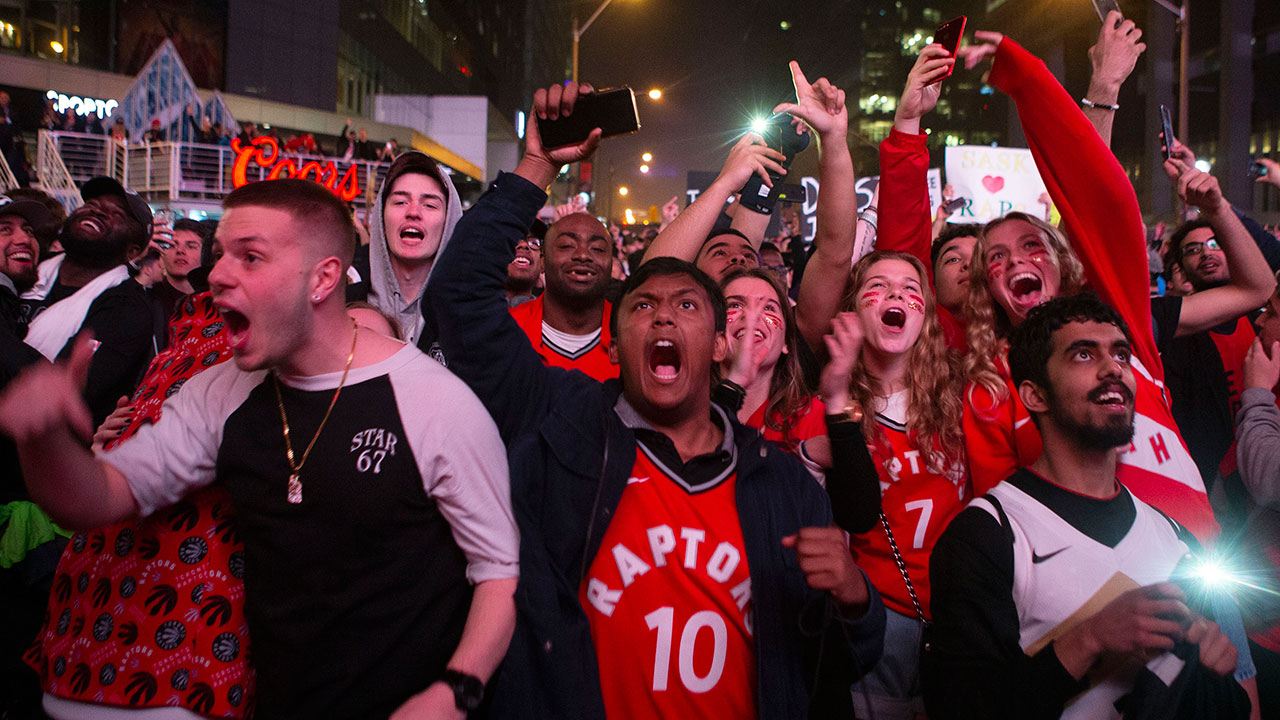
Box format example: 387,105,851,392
579,447,756,720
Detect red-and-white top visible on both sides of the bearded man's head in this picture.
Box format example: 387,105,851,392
962,354,1219,538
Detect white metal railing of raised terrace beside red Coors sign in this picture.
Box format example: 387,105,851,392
37,131,390,209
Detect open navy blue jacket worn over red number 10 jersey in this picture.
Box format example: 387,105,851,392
424,174,884,719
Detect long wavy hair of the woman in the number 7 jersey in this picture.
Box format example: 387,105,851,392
841,250,964,474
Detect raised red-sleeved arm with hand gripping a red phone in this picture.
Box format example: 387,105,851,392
876,44,955,269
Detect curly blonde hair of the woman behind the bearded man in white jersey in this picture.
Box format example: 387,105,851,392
964,213,1084,413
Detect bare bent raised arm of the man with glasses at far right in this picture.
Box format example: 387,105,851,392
1165,159,1276,337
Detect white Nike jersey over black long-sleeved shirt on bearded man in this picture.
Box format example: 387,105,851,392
922,468,1196,720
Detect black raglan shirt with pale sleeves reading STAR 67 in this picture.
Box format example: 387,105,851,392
100,345,520,717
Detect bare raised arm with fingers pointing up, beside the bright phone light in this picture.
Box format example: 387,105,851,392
773,60,858,351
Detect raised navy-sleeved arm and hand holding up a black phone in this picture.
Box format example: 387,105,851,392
422,78,600,442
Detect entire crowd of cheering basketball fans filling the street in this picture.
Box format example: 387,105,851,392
0,14,1280,719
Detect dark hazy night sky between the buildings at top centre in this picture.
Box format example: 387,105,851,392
577,0,880,215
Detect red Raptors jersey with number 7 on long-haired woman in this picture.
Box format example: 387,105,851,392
850,392,969,618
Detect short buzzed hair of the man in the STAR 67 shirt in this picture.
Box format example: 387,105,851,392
223,178,356,268
